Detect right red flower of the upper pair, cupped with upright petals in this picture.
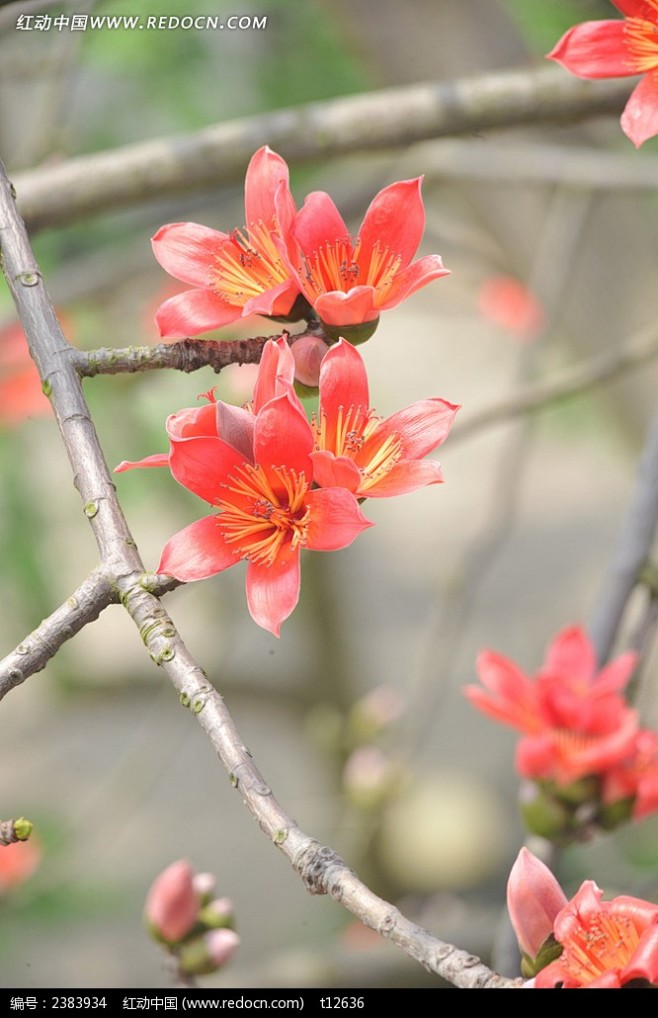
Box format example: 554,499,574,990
287,177,449,338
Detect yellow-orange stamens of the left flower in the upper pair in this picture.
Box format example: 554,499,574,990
212,220,289,307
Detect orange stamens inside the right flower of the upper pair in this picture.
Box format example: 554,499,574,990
299,237,401,304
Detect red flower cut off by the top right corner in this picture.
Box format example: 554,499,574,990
548,0,658,148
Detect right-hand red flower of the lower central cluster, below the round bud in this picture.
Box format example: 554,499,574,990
312,339,459,498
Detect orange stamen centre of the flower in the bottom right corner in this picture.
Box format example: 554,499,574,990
560,911,640,984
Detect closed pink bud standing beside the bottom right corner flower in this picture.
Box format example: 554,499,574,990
507,848,566,958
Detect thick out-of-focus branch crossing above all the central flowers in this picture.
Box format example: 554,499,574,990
14,67,632,231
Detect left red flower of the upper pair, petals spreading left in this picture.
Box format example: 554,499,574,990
153,146,299,339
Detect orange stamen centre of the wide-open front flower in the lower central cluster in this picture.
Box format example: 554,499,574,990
217,463,311,566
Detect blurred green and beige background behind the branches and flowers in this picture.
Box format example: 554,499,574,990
0,0,658,987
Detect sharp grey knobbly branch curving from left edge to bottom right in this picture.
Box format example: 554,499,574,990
0,158,519,987
